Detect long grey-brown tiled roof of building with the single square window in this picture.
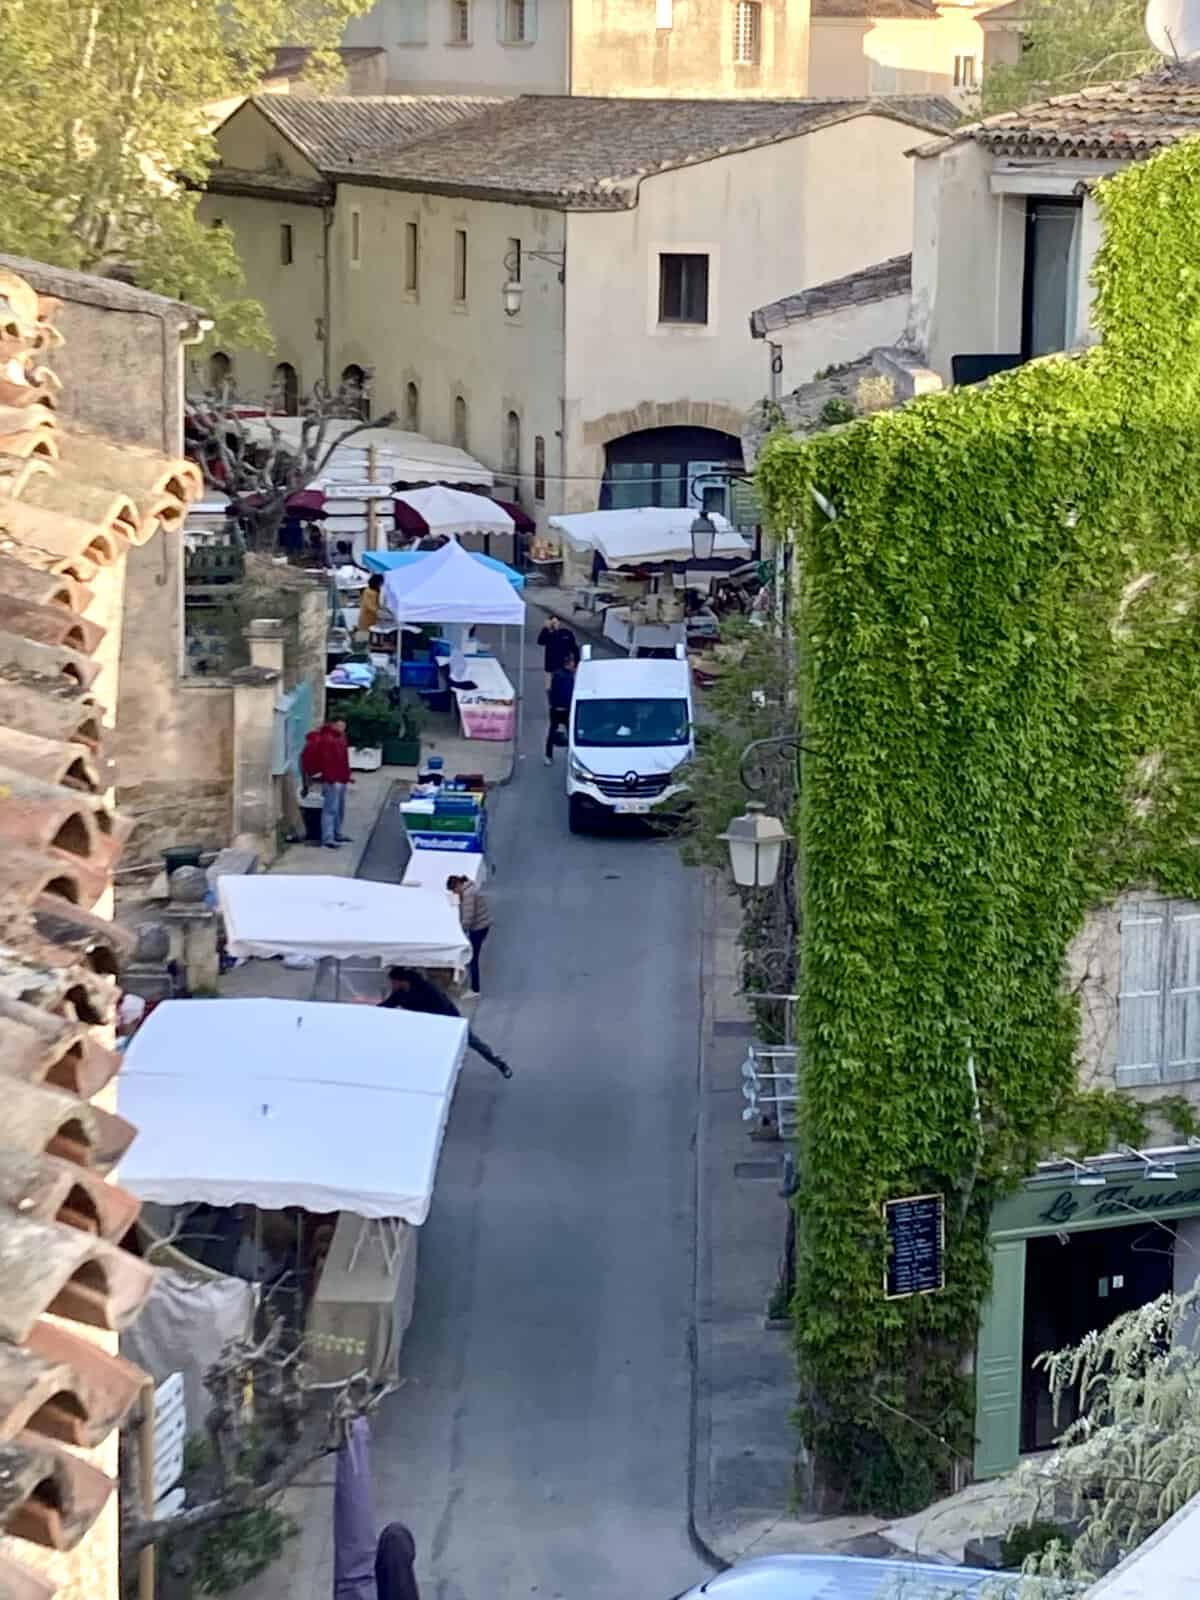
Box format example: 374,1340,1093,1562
316,94,958,210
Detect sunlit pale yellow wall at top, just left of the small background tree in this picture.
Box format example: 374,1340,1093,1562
808,5,986,100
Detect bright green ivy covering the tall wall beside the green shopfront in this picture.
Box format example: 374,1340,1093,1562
758,142,1200,1510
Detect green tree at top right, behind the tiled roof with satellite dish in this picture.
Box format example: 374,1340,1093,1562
984,0,1160,117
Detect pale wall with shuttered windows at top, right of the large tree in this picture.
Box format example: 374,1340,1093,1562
344,0,571,94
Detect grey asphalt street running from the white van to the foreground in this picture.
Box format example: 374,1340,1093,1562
368,624,707,1600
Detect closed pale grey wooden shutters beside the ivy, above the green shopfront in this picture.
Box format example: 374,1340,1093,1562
1117,901,1200,1088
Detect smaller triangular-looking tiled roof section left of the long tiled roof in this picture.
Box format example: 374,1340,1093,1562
256,94,502,171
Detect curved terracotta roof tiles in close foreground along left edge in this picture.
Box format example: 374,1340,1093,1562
0,269,200,1600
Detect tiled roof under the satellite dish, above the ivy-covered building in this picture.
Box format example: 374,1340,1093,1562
915,67,1200,162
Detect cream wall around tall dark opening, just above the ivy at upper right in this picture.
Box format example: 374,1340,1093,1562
909,141,1101,382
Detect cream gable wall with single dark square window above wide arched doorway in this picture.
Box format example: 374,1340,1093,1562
566,117,914,507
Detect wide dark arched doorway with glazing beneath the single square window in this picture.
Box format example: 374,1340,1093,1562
600,427,742,512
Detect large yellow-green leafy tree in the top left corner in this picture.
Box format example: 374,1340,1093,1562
0,0,370,337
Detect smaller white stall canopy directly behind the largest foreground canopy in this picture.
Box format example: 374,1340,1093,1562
216,872,470,971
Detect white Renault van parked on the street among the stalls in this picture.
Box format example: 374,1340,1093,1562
566,645,694,834
